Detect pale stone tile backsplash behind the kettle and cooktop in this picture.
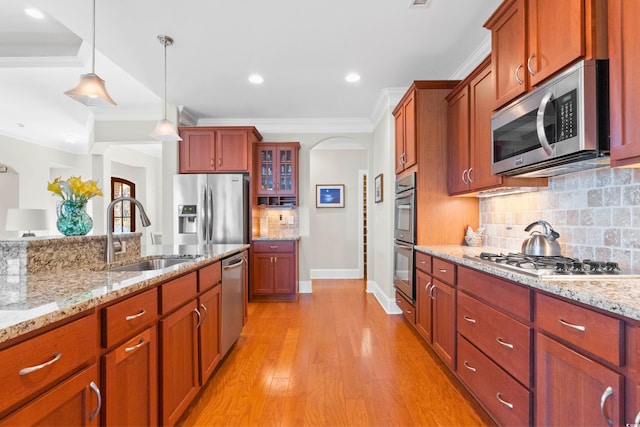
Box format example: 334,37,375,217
480,167,640,269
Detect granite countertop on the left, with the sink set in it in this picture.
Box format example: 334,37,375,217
0,244,249,343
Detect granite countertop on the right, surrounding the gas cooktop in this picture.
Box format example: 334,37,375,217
416,246,640,321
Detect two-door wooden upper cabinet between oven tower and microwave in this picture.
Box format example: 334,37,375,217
447,57,547,195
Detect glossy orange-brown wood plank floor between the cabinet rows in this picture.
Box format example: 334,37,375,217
179,280,493,427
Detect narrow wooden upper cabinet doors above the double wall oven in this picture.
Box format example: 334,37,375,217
393,89,417,174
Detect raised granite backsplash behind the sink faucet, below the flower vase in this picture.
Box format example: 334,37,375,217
0,233,142,275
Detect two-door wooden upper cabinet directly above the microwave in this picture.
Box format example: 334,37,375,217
485,0,607,109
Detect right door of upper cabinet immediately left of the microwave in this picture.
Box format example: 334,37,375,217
468,61,502,190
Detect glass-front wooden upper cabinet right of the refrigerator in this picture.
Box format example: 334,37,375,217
254,142,300,206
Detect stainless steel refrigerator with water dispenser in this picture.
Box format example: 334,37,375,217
173,174,249,245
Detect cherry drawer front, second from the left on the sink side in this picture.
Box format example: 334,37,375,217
102,288,158,348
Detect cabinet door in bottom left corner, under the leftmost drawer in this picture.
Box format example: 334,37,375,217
0,365,101,427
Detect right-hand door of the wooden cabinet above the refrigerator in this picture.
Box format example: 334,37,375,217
215,129,249,172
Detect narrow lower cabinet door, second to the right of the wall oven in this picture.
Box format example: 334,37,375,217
431,280,456,369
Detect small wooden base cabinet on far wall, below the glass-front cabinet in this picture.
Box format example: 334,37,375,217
250,240,298,300
